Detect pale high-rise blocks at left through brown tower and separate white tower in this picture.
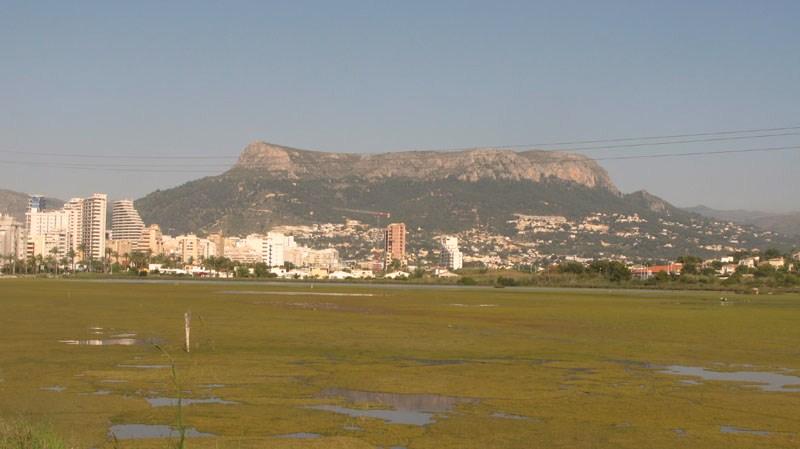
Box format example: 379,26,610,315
0,193,463,278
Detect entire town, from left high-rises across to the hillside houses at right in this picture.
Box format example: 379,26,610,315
0,193,800,279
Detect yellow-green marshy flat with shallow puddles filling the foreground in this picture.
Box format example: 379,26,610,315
0,279,800,449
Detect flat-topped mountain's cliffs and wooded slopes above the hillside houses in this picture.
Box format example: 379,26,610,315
136,142,624,233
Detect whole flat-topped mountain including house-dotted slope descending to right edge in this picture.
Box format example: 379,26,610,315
136,142,795,257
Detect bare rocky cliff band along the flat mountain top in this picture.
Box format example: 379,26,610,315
234,142,617,192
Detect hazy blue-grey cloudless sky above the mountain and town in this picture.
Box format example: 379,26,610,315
0,0,800,212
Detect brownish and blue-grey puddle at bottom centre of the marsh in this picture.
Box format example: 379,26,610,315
308,388,477,426
